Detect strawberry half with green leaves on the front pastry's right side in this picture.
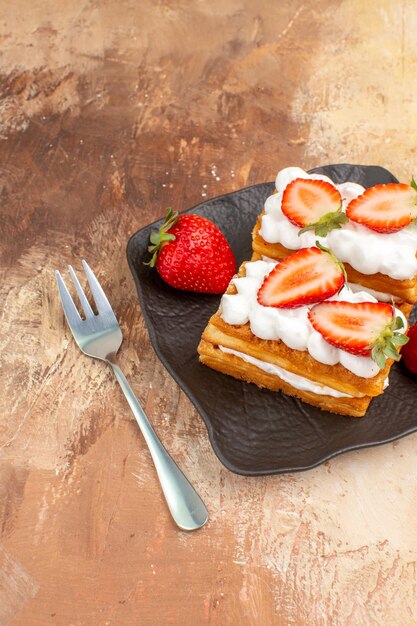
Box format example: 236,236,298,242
308,301,407,369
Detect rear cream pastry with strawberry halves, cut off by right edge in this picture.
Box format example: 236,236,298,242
253,167,417,303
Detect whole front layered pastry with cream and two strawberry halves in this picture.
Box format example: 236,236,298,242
198,247,411,417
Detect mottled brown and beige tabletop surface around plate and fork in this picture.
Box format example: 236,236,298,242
0,0,417,626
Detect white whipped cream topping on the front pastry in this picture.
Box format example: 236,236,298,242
221,261,407,378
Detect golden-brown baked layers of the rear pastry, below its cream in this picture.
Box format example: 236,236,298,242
252,213,417,304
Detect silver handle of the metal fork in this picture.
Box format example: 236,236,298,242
108,361,208,530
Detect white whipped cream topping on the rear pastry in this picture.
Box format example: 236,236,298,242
260,167,417,280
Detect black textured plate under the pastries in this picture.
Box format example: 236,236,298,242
127,164,417,476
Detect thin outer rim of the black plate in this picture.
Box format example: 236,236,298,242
126,163,417,477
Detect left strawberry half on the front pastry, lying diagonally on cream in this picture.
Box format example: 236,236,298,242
258,248,345,309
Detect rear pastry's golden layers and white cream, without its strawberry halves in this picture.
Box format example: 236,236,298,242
252,167,417,304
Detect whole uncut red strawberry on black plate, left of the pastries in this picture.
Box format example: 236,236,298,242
148,209,236,293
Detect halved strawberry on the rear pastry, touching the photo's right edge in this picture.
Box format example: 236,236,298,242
346,180,417,233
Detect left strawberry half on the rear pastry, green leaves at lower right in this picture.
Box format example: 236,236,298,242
281,178,347,237
